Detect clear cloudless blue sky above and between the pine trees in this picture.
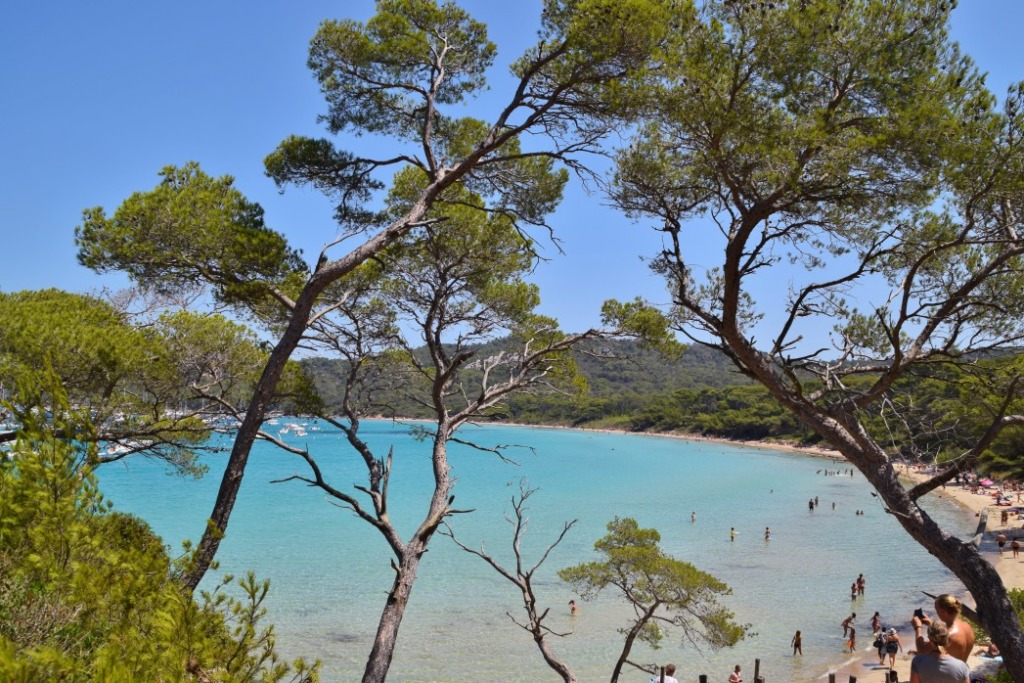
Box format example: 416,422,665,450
0,0,1024,330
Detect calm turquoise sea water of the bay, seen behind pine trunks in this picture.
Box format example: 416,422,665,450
100,422,972,683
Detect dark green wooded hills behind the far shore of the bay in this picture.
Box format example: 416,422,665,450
302,340,1024,476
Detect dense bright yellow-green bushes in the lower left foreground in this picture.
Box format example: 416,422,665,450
0,378,318,683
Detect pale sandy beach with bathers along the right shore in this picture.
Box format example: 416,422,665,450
825,471,1024,683
